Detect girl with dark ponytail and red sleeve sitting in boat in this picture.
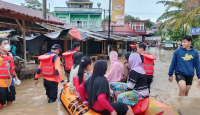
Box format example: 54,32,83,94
73,56,92,99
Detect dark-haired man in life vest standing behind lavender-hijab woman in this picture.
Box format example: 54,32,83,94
137,43,156,93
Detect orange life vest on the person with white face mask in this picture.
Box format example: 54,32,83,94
0,53,15,79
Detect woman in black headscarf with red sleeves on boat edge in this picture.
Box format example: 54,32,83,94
79,60,134,115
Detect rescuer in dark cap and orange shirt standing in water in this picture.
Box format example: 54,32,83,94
35,44,65,103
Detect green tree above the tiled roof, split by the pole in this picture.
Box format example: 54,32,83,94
21,0,54,14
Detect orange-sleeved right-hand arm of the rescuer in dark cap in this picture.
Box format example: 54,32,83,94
55,57,64,83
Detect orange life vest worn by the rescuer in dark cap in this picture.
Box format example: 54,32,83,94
38,54,56,78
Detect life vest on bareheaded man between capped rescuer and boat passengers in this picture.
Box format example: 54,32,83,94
62,51,77,71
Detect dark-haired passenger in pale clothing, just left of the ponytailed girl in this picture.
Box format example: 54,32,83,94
69,52,84,94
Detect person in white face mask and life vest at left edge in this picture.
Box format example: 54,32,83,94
0,38,19,105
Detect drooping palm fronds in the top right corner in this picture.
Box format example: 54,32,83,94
157,0,200,29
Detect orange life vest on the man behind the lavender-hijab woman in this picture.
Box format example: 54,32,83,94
142,53,156,75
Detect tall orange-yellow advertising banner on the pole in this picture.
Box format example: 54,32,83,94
111,0,125,26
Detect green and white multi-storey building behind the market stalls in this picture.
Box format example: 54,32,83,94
54,0,103,31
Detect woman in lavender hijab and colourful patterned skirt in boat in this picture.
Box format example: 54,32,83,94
110,53,149,106
